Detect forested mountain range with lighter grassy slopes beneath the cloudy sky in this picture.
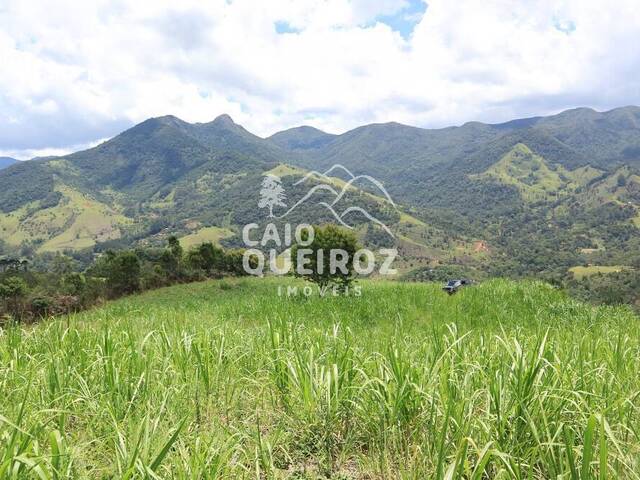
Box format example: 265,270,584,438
0,106,640,284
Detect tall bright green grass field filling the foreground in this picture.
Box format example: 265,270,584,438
0,279,640,480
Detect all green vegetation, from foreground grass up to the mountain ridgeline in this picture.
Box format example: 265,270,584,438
0,95,640,480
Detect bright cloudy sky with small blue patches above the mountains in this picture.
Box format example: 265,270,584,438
0,0,640,159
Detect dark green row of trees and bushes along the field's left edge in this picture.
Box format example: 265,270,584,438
0,237,250,326
